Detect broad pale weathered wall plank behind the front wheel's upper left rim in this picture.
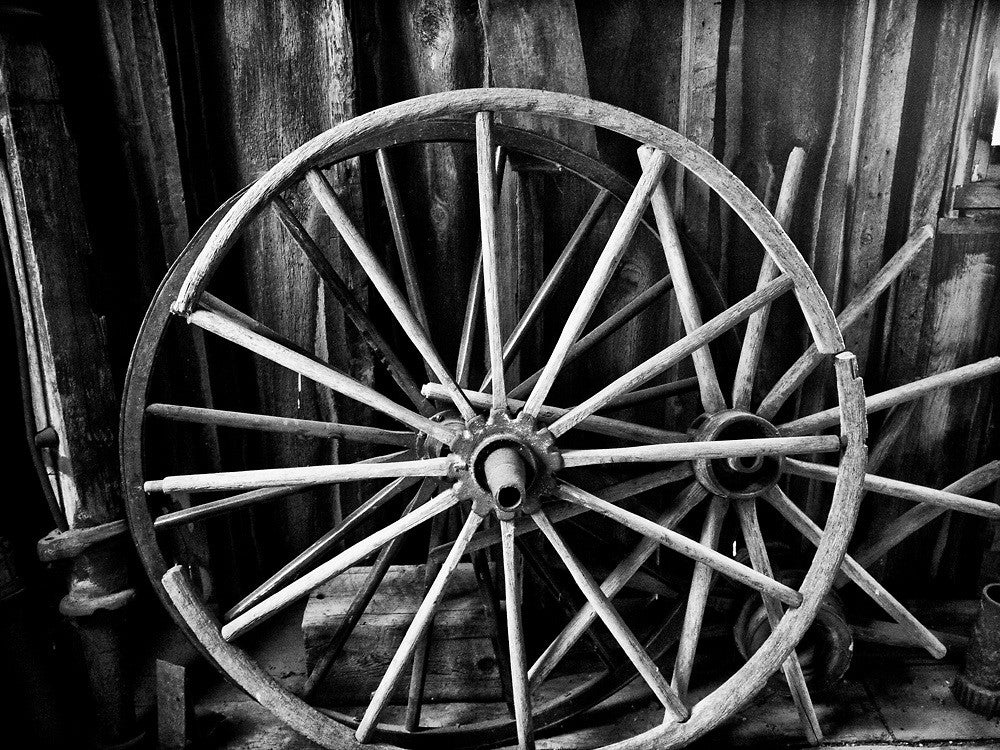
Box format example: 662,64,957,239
211,0,364,558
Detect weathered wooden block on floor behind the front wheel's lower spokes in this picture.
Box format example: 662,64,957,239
302,563,502,705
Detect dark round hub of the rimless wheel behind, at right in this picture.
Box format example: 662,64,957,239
690,409,784,500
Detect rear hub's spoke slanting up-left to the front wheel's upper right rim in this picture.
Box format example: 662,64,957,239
639,146,726,412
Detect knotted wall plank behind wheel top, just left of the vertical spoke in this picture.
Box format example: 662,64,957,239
366,0,485,370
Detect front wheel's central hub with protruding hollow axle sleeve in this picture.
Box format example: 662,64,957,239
451,413,562,518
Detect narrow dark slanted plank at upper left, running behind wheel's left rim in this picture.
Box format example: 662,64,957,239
98,0,225,590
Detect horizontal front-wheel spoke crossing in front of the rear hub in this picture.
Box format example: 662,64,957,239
562,435,840,468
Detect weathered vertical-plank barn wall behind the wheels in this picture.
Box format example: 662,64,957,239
3,0,1000,612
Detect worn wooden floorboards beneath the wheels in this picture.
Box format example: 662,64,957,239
189,613,1000,750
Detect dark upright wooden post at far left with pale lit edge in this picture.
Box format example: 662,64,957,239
0,26,135,744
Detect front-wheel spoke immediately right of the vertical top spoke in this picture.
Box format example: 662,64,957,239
520,147,667,417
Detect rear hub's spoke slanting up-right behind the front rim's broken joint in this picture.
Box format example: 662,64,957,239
757,225,934,419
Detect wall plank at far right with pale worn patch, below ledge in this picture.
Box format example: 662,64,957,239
888,218,1000,596
